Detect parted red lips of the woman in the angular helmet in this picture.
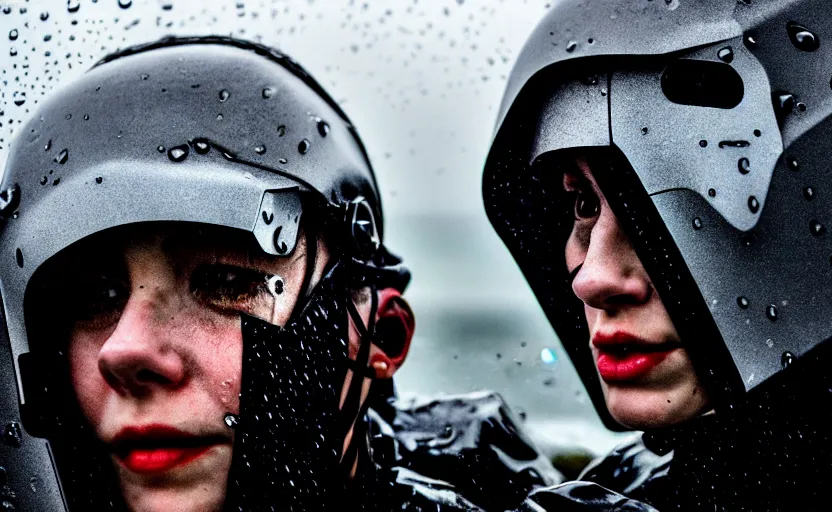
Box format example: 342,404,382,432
592,332,681,382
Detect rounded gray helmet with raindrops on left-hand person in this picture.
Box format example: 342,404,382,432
0,37,409,510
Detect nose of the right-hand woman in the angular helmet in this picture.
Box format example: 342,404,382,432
572,209,652,311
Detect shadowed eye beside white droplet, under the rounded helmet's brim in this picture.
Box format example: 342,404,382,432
191,265,270,313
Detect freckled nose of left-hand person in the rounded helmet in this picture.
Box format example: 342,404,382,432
98,297,185,396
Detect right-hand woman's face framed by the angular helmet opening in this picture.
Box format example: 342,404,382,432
563,158,707,430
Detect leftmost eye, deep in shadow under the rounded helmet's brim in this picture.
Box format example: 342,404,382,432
66,274,130,327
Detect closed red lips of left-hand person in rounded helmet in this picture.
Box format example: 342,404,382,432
112,425,228,474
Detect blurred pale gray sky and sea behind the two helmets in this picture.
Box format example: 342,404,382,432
0,0,621,453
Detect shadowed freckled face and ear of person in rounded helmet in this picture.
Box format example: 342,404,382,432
52,225,412,511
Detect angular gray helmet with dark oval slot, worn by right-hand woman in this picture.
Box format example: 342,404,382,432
483,0,832,429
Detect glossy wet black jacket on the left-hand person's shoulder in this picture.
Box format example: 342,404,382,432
370,393,655,512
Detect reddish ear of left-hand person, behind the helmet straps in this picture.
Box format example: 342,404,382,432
370,288,415,379
